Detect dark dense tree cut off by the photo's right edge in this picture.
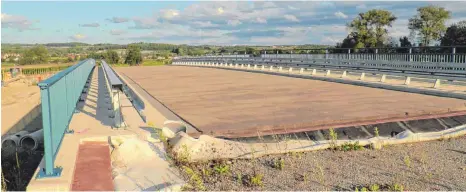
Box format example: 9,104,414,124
440,20,466,53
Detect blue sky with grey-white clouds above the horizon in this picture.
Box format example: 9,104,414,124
1,1,466,45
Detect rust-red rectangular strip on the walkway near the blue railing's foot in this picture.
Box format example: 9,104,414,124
71,142,114,191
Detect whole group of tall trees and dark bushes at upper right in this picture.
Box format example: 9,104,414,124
336,5,466,52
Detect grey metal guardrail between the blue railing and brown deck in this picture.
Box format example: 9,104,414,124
101,60,124,128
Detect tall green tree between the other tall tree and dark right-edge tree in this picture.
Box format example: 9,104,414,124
408,5,451,46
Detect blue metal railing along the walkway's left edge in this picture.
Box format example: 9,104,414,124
38,59,95,177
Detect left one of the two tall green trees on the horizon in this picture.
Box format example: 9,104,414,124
348,9,396,48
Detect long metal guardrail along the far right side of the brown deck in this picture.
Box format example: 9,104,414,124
174,57,466,80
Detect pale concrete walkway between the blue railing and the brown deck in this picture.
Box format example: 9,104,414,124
27,67,184,191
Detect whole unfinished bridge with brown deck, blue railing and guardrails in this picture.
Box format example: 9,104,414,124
23,47,466,190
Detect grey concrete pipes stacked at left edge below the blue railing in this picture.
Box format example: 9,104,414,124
2,129,44,150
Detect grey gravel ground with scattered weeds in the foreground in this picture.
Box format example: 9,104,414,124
177,136,466,191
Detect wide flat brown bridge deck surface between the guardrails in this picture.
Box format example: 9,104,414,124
117,66,466,137
